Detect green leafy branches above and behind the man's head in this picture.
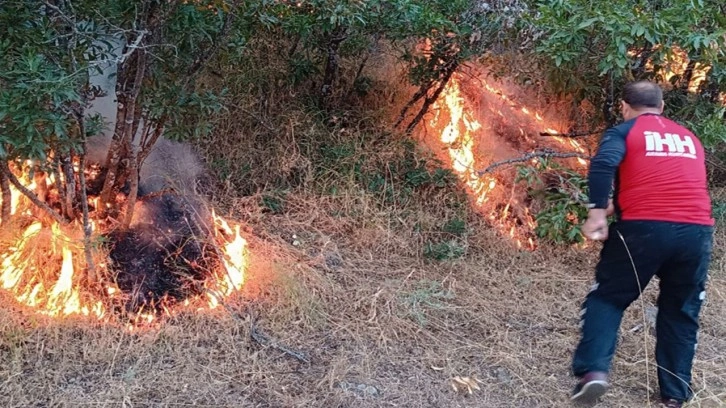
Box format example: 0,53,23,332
528,0,726,147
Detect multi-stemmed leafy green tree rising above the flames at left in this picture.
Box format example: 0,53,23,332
0,0,237,230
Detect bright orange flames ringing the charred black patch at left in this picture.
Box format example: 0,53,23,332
0,167,247,327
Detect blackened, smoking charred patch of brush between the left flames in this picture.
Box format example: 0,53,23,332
108,192,220,313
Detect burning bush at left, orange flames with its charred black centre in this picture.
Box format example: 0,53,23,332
0,155,245,320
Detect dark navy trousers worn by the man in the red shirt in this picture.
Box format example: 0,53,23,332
572,221,713,401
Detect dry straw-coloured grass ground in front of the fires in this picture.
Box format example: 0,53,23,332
0,192,726,408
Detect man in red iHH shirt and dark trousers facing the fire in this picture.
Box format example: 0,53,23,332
572,81,714,407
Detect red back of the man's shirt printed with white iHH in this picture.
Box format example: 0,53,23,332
616,114,714,225
